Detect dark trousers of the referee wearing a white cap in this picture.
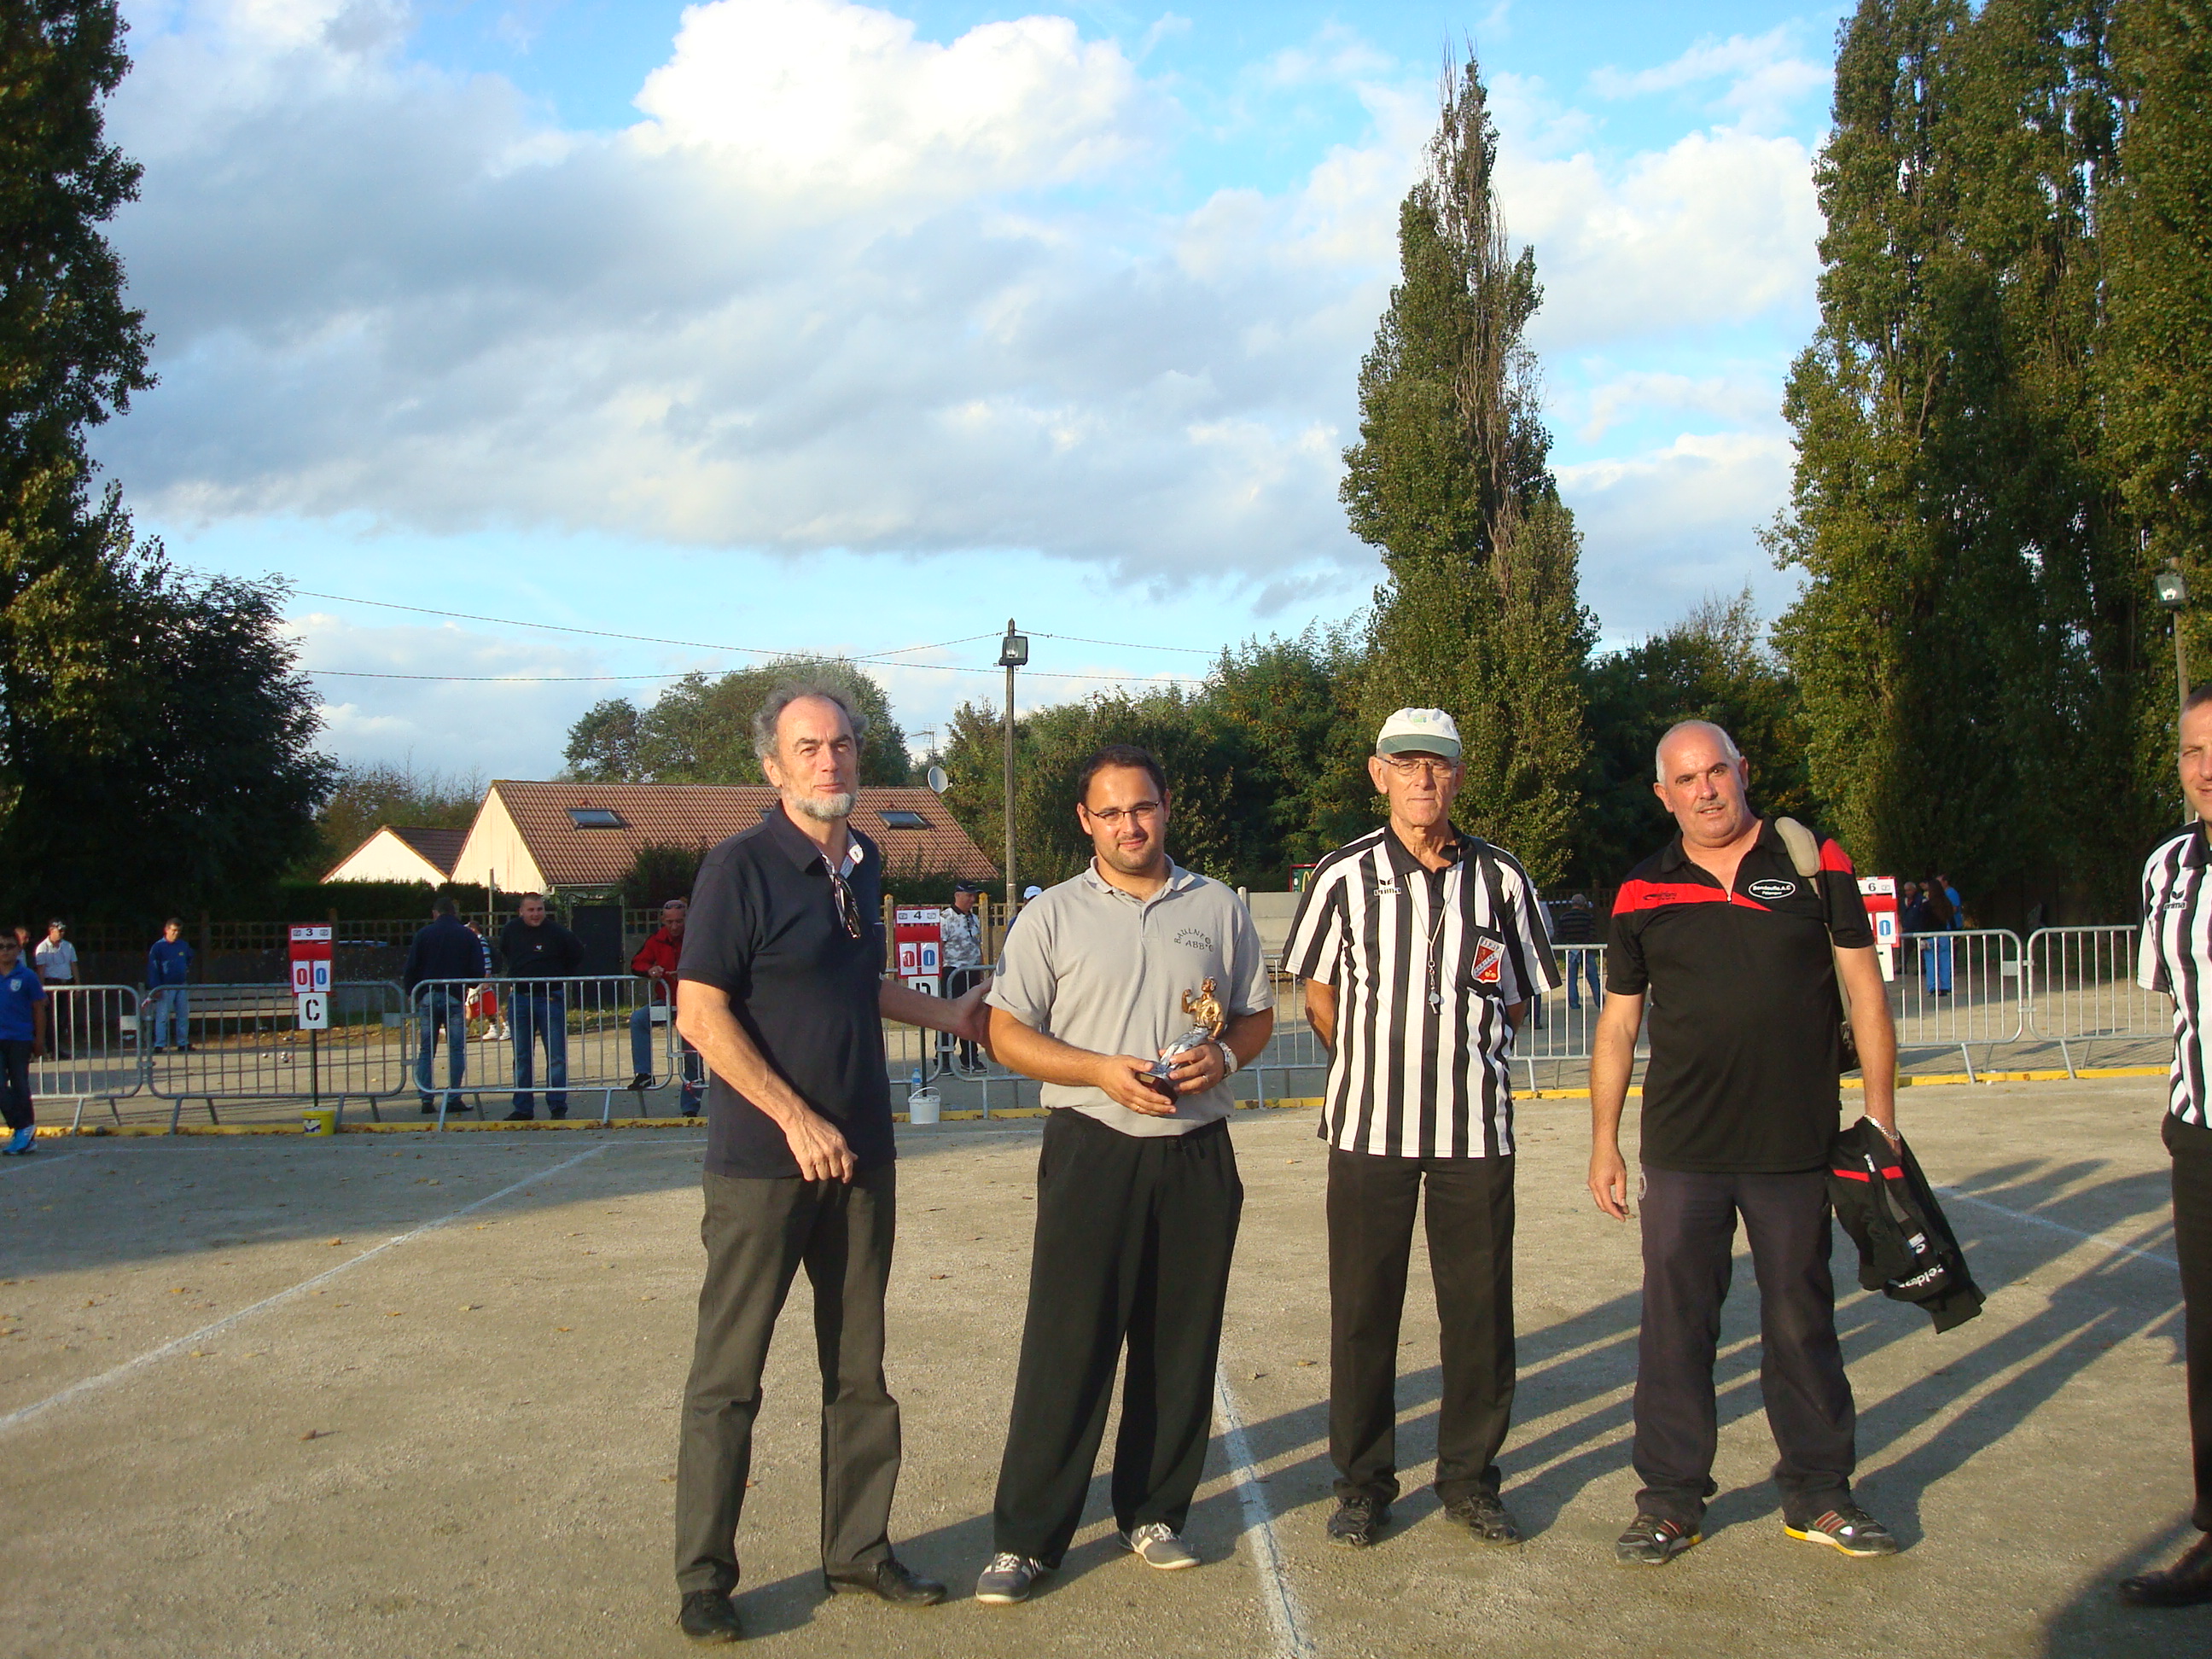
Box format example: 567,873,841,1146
1330,1148,1516,1505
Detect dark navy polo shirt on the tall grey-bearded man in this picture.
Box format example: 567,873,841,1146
677,805,896,1177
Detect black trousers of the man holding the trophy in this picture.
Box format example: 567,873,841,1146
991,1110,1243,1566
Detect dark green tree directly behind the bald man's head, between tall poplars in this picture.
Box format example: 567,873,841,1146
1566,588,1820,887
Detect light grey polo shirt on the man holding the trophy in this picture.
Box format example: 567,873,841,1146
987,863,1272,1135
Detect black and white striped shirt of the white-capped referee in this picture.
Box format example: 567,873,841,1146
1283,825,1559,1157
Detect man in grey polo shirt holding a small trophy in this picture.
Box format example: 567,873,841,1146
975,743,1274,1602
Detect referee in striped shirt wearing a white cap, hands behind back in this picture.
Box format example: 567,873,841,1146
1283,707,1559,1546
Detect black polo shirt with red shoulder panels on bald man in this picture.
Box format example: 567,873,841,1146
1606,818,1873,1174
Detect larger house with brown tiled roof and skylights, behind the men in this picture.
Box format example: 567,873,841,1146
422,778,998,896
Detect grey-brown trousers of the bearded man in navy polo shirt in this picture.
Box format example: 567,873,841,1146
677,1163,900,1592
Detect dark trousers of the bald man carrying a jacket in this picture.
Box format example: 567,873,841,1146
1634,1168,1858,1526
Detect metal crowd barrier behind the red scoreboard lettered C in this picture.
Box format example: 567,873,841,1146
137,980,407,1131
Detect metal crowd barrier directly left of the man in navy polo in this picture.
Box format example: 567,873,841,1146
400,973,681,1128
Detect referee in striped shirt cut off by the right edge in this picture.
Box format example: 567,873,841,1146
2119,686,2212,1608
